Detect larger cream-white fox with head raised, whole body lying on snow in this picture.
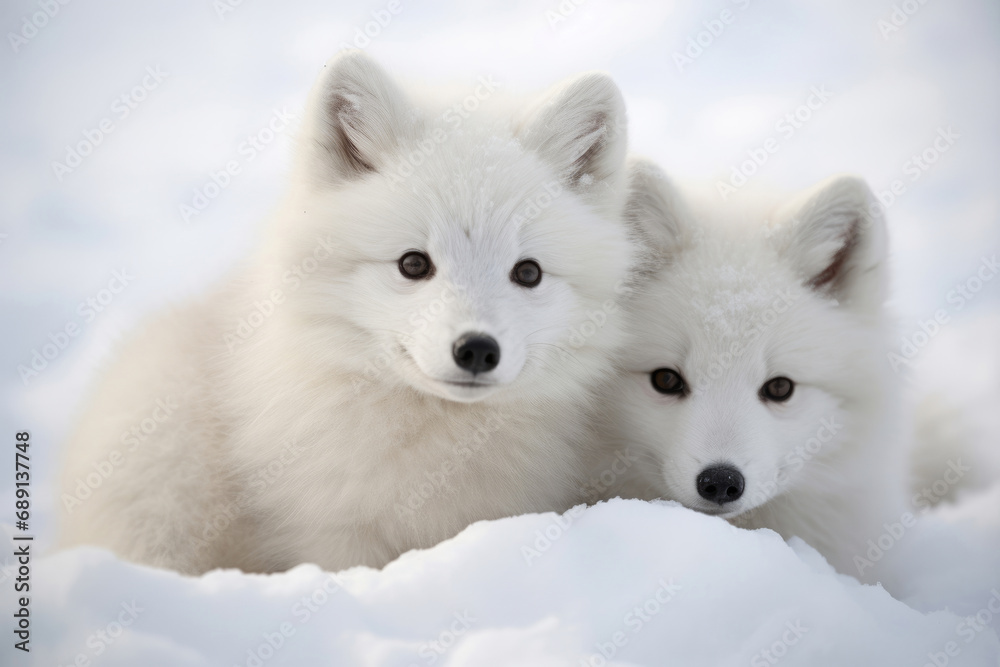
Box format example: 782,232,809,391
61,52,636,572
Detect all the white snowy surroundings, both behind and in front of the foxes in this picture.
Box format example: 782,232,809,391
0,0,1000,667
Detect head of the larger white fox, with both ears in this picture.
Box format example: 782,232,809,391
271,51,632,402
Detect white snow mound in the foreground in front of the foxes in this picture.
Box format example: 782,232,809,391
4,498,1000,667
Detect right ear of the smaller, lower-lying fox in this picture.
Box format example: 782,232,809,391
773,176,888,308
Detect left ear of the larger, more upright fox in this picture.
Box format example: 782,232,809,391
300,50,417,182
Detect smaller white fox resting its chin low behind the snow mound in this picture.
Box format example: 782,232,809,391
605,161,912,577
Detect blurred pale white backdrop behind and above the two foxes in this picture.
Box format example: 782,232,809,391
0,0,1000,552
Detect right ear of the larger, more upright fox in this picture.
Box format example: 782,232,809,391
519,73,627,204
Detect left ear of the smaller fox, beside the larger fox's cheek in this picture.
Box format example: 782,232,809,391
625,157,692,264
